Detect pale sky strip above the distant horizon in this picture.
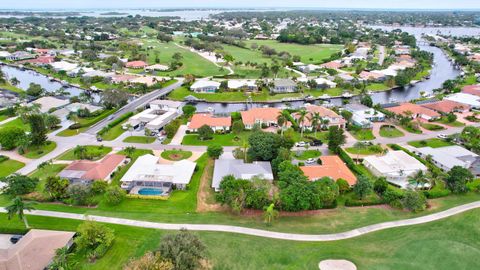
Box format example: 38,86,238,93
0,0,480,10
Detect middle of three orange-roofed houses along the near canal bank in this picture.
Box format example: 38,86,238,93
240,108,281,129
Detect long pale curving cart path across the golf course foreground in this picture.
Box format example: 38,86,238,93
0,201,480,242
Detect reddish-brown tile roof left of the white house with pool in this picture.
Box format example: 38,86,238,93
65,154,125,180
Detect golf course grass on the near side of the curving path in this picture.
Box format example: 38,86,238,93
0,201,480,270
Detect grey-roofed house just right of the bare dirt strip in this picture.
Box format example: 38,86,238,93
212,157,273,191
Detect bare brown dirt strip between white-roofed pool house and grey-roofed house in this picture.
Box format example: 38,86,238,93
197,159,228,213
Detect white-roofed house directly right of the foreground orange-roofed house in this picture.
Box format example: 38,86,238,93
363,150,428,188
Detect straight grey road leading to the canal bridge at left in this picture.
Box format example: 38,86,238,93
85,78,183,135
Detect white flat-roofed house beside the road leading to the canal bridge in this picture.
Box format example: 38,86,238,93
122,100,182,130
